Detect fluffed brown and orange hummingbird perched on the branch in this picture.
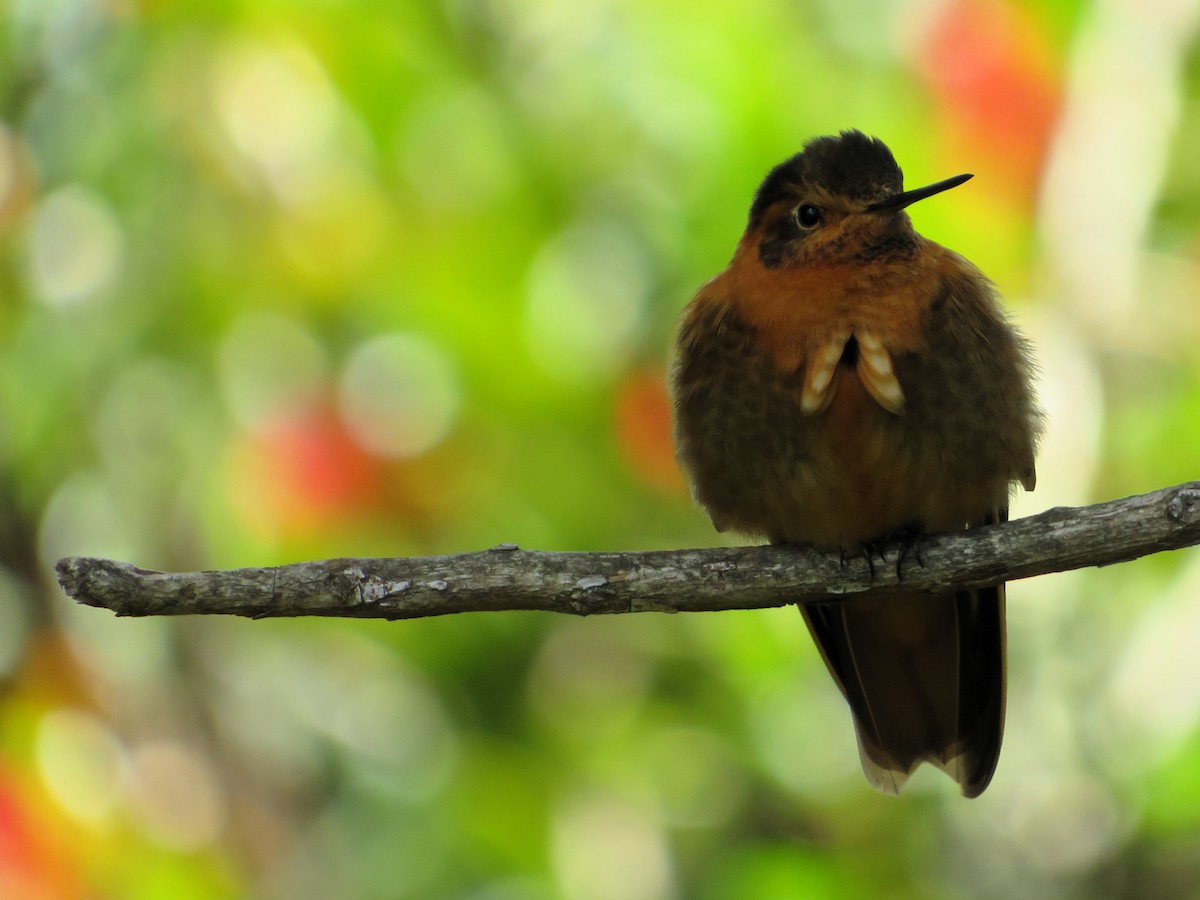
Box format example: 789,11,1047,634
671,131,1040,797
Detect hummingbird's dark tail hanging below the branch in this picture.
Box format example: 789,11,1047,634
802,586,1004,797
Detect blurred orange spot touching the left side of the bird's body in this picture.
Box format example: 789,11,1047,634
616,368,684,493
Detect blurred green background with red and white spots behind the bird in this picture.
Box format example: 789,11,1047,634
0,0,1200,900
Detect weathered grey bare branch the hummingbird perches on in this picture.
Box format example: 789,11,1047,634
56,481,1200,619
